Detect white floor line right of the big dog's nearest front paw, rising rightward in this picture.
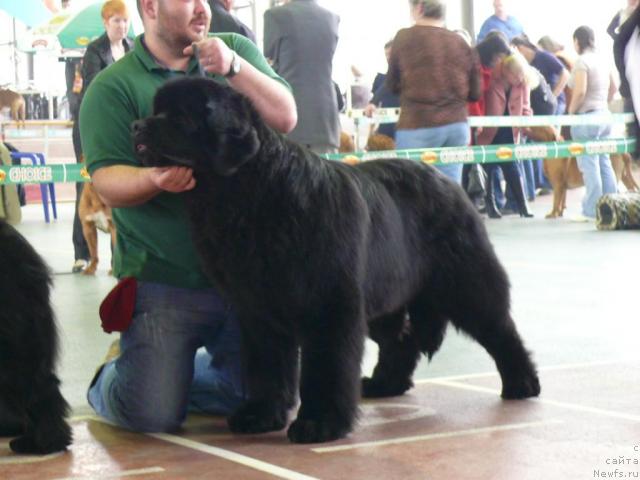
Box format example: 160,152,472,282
311,420,562,453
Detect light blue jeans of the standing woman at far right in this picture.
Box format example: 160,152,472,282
571,111,618,218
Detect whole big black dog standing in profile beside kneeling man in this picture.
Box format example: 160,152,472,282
133,78,540,443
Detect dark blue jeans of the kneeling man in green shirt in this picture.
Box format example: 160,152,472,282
87,282,246,432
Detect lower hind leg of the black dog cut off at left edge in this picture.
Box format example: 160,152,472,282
9,373,72,454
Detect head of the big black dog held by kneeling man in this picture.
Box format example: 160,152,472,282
132,77,261,176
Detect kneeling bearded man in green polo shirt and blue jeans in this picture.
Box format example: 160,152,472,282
80,0,297,432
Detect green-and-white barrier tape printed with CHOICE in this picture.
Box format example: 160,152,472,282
0,138,636,185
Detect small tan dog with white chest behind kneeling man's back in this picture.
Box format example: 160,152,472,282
78,175,116,275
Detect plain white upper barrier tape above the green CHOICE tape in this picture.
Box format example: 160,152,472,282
347,108,635,127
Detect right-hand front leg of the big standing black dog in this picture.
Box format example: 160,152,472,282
287,299,366,443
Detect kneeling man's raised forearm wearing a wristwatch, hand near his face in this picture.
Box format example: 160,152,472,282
184,37,298,133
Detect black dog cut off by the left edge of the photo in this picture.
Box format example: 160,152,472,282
0,220,71,454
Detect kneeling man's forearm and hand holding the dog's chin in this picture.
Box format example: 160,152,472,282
91,165,196,207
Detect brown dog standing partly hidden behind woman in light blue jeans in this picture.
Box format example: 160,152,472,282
527,127,640,218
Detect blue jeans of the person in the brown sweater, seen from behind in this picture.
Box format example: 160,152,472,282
396,122,471,185
